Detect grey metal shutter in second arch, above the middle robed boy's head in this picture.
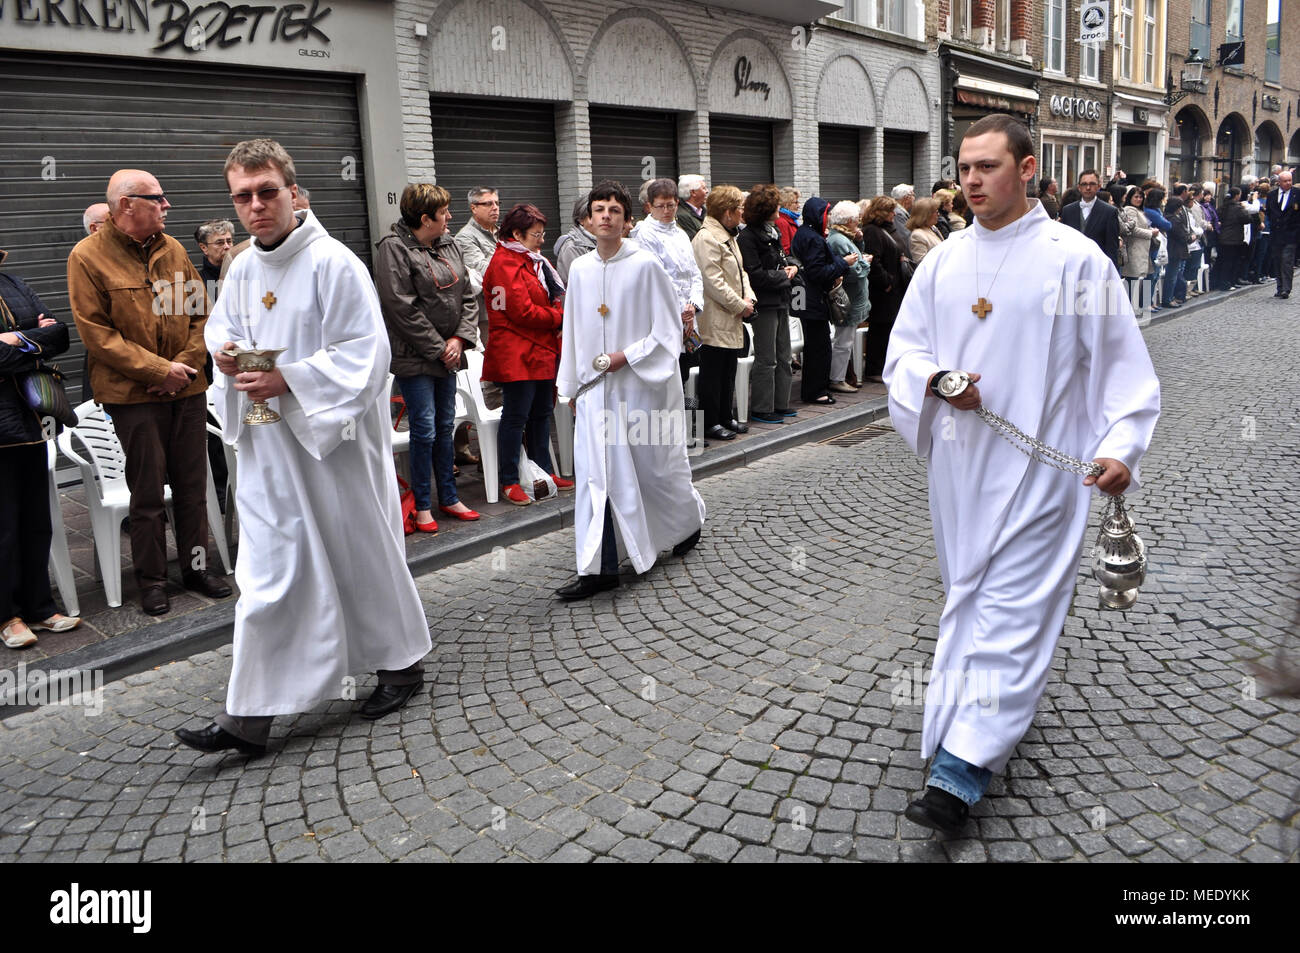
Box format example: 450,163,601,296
589,105,677,197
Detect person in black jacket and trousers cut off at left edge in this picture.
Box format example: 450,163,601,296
0,251,81,649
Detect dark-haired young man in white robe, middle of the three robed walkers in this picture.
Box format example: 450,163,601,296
555,182,705,599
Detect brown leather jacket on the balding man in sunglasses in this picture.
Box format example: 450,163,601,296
68,218,209,404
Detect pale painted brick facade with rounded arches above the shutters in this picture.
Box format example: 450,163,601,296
394,0,940,198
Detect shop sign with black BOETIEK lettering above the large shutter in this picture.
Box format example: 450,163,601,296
0,0,332,56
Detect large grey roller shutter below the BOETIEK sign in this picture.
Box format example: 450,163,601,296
0,51,371,403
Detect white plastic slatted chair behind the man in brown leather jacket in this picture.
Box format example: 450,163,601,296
59,400,233,607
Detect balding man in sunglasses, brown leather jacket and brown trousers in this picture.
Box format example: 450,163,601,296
68,169,230,615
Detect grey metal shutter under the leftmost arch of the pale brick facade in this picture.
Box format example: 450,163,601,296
429,96,559,256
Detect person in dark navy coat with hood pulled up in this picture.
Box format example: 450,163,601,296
790,195,858,406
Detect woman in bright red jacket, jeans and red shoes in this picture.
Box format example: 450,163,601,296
484,205,573,506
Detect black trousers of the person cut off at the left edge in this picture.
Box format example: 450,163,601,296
0,443,59,625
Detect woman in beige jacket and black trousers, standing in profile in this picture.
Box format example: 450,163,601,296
690,185,757,439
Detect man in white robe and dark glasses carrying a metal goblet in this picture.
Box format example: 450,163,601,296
176,139,432,754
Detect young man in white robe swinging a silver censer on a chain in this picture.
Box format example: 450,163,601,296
884,114,1160,833
